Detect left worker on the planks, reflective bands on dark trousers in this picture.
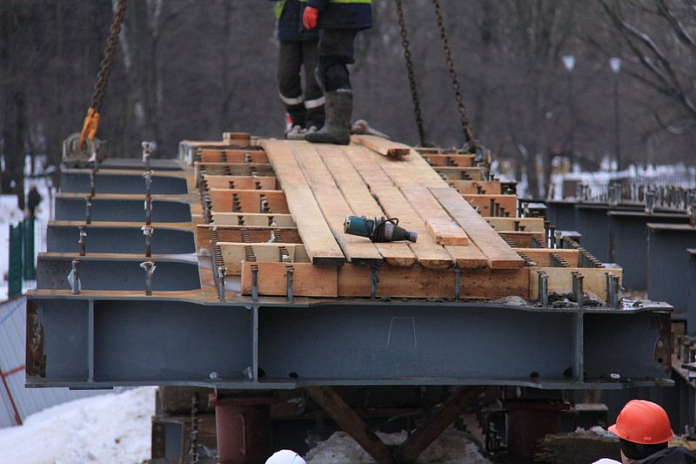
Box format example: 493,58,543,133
273,0,325,139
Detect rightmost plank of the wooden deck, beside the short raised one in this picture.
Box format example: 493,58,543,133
430,188,524,269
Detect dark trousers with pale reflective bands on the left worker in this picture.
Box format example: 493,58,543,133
277,40,324,128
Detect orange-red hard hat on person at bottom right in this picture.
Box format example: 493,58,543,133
609,400,674,445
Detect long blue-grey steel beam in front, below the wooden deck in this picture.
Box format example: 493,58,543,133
27,294,670,389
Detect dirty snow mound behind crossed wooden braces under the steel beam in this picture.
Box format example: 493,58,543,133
305,429,491,464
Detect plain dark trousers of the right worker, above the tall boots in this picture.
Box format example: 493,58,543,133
319,29,357,92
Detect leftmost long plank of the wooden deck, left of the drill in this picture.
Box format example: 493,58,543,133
261,140,345,264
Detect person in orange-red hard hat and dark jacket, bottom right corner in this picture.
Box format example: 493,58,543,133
594,400,696,464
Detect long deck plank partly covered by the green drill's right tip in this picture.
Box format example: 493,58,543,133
343,145,455,269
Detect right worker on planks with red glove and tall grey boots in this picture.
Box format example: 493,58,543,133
302,0,372,145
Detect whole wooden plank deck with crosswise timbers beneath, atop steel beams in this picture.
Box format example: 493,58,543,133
189,135,620,298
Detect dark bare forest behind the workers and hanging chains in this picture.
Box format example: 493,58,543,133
0,0,696,203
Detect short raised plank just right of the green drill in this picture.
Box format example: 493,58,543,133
401,187,469,246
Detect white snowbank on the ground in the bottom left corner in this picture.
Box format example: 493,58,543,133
0,387,156,464
